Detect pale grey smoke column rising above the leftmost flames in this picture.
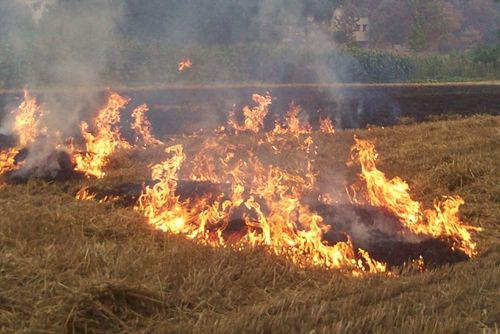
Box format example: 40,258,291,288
1,0,123,176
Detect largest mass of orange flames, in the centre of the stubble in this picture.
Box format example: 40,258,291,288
136,139,386,275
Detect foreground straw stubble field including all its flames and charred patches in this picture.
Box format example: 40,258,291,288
0,93,500,333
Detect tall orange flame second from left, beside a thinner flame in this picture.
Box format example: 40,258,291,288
74,93,130,178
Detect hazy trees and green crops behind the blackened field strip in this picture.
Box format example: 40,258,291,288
0,0,500,88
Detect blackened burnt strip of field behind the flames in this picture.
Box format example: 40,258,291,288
0,81,500,139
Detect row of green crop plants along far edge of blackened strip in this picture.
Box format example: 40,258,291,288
0,40,500,88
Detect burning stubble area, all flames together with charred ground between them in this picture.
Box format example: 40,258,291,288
0,92,480,276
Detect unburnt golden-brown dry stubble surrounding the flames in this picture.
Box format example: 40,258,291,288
0,116,500,333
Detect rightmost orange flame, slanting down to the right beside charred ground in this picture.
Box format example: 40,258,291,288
352,138,480,257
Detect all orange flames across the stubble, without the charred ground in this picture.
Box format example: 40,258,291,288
0,92,480,275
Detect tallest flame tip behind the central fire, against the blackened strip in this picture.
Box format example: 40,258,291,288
228,94,272,133
